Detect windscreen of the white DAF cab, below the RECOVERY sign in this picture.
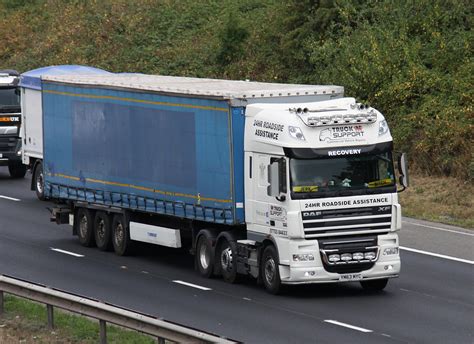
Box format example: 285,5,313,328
290,152,396,199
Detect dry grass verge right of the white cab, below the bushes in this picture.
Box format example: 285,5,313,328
399,175,474,229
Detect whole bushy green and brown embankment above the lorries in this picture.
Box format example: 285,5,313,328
0,0,474,178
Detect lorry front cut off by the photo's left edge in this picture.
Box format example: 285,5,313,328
0,69,26,178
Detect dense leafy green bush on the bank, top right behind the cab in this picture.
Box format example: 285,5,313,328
302,0,474,177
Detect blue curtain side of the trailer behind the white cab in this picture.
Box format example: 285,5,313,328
43,81,244,225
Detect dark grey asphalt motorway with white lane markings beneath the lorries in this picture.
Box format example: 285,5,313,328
0,167,474,343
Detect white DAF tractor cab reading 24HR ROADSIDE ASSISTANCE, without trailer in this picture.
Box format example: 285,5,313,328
245,98,408,292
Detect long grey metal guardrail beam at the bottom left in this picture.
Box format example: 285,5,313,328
0,275,236,343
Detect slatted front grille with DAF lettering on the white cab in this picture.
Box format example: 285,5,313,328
302,206,392,239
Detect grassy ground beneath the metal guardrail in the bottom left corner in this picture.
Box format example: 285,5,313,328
0,295,156,344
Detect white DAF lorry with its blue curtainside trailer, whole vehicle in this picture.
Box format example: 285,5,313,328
38,75,407,293
